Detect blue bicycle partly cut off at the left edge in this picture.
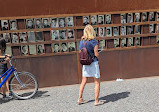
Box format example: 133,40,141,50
0,56,38,100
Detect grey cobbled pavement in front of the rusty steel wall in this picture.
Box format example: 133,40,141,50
0,77,159,112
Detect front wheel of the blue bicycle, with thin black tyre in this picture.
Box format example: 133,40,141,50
9,72,38,99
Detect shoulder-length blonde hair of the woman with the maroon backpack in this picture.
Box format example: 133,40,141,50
81,25,96,40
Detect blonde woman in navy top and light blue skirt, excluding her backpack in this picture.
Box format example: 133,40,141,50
78,25,104,106
